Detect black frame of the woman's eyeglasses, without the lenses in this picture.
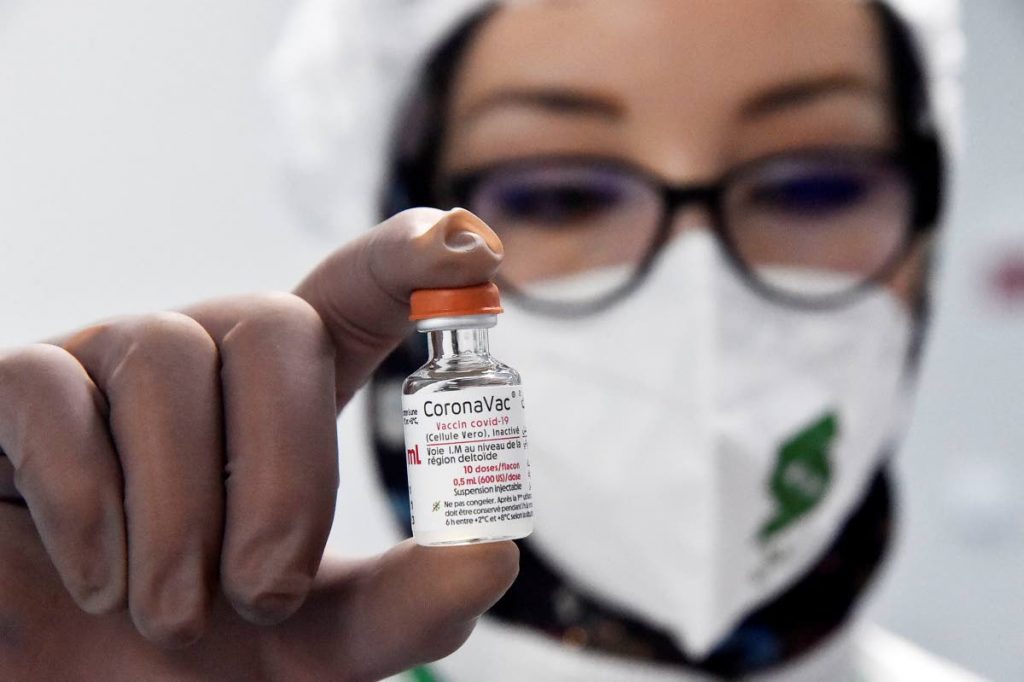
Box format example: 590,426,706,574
442,145,937,317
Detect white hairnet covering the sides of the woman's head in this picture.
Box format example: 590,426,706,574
269,0,964,236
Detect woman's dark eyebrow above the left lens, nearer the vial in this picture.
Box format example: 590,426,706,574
461,87,626,123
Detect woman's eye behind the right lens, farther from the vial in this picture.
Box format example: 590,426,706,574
748,170,872,217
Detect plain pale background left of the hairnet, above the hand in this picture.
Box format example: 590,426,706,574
0,0,325,337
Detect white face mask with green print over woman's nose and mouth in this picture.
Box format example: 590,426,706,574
494,230,912,657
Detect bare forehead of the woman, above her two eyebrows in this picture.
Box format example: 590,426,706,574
454,0,887,119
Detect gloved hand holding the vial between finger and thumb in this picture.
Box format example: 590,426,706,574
0,209,518,680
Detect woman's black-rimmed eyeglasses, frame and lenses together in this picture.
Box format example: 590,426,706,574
447,147,922,315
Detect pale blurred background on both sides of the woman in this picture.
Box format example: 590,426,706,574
0,0,1024,681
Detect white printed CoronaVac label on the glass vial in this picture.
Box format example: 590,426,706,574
401,386,534,544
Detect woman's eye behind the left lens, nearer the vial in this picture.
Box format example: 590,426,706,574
494,181,627,226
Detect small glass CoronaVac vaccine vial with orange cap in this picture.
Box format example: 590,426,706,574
401,284,534,546
